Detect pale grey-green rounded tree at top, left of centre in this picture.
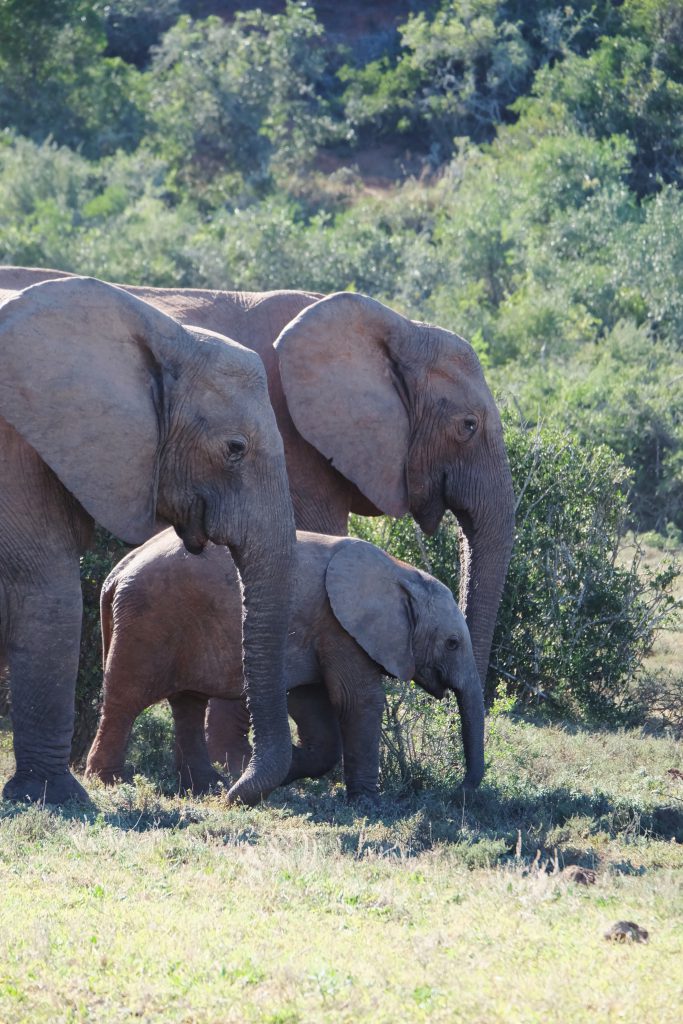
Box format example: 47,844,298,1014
145,2,331,191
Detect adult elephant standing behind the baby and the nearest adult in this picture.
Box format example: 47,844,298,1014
0,267,514,759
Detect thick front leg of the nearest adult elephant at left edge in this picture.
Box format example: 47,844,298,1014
3,577,88,804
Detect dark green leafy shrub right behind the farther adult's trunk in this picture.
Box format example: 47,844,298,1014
353,420,677,721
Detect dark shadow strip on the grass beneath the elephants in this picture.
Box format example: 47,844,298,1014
0,741,683,873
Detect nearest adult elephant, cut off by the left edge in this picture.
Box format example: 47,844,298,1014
0,278,295,803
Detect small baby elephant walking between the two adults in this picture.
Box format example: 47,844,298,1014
86,529,484,797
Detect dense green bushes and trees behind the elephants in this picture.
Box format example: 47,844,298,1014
0,0,683,733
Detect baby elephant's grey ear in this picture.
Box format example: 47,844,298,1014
325,539,415,679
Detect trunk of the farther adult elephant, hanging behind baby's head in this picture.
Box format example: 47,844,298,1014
451,455,514,703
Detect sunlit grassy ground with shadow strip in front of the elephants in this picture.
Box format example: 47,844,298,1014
0,716,683,1024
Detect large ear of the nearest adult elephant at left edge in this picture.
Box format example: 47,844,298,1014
0,278,184,544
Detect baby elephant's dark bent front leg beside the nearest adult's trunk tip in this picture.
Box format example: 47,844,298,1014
285,685,342,783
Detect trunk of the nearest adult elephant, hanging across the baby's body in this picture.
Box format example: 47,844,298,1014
228,463,295,804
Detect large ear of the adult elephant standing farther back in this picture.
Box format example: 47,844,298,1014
275,292,412,516
